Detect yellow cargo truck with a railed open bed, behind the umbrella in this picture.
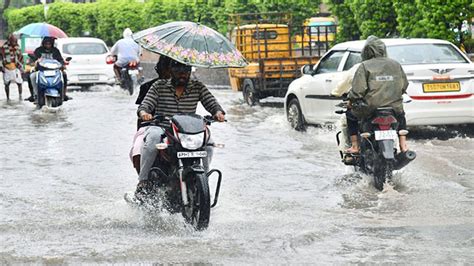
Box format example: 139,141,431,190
229,13,336,105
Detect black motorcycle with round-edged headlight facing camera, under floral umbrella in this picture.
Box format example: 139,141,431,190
125,114,222,230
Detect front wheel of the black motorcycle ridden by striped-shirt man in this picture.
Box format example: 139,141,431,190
182,174,211,231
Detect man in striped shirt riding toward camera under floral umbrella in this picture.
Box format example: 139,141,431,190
135,61,225,196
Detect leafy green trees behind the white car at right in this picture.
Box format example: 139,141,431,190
325,0,474,45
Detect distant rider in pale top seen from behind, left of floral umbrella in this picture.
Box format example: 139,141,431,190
110,28,141,83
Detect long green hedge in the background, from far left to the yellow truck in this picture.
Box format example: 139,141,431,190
5,0,326,44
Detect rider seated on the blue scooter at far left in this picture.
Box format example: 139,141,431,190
29,37,72,101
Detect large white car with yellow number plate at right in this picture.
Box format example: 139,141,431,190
285,39,474,129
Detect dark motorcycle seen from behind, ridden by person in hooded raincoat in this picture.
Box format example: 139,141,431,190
336,102,416,190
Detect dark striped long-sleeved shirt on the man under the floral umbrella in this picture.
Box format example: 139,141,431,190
137,79,225,128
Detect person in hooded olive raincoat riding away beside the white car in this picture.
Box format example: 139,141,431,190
347,36,408,153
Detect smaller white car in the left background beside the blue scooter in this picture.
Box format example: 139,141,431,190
56,37,115,87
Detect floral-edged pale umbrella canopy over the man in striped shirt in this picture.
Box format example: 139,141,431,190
133,21,247,68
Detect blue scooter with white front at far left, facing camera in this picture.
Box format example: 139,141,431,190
36,57,71,109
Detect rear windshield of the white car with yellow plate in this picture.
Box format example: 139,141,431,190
387,43,467,65
